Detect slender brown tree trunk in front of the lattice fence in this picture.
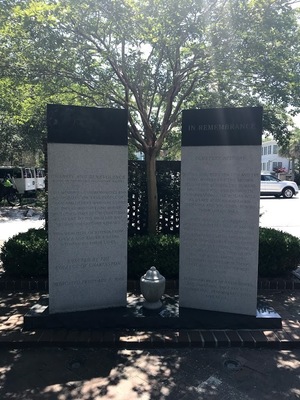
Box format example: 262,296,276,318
145,149,158,235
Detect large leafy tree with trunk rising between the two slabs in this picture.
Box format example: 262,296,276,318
0,0,300,233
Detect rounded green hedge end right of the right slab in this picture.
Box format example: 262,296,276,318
258,228,300,277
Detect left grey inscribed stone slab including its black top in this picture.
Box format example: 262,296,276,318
48,105,128,313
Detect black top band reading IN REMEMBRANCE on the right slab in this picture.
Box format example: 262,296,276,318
182,107,263,146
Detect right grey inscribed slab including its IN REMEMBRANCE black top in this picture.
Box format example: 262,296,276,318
179,107,262,315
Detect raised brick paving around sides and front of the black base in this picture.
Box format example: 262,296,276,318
0,289,300,349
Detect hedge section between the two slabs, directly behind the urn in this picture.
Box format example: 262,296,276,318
128,235,179,279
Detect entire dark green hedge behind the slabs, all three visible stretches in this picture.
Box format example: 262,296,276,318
0,228,300,279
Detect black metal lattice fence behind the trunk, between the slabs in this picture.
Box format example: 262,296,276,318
128,161,180,236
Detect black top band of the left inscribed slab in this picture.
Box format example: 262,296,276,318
47,104,128,146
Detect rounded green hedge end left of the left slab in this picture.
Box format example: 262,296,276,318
0,229,48,278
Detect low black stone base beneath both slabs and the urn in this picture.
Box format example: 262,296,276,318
23,295,282,330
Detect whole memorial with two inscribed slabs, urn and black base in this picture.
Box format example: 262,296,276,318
23,105,281,330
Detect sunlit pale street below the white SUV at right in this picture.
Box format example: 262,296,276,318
260,194,300,238
